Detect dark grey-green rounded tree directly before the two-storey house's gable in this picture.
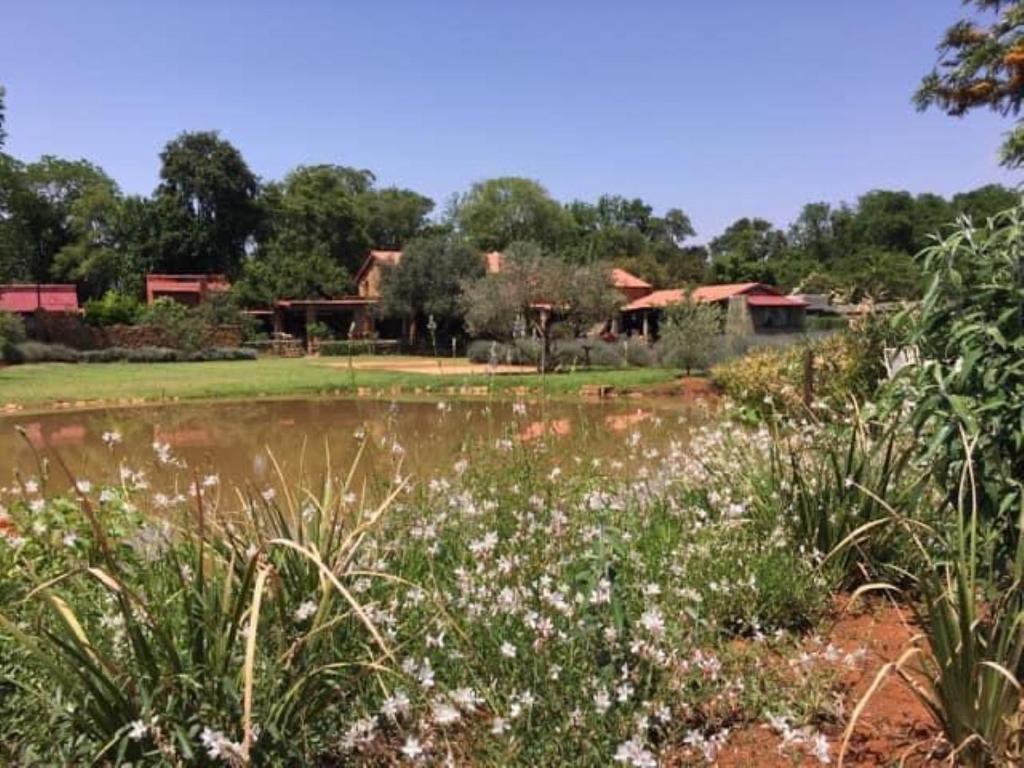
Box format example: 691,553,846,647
380,236,484,343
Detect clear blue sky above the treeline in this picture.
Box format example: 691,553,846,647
0,0,1017,240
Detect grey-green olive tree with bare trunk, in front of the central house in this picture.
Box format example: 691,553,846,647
463,243,622,370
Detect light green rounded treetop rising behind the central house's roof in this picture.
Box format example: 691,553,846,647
450,176,570,251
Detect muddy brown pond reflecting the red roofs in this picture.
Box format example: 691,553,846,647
0,398,702,488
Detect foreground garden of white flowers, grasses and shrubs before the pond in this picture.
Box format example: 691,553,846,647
0,199,1024,767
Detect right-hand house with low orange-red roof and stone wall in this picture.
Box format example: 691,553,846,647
622,283,807,338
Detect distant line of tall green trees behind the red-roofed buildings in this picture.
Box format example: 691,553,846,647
0,81,1018,305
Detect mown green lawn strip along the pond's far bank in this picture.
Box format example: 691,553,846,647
0,357,677,409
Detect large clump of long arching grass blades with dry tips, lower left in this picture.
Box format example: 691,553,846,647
0,448,407,765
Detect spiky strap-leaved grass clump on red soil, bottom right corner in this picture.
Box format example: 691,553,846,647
840,437,1024,768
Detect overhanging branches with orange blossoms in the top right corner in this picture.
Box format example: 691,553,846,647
914,0,1024,168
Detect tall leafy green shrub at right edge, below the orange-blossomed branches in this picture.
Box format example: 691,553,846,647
899,207,1024,536
